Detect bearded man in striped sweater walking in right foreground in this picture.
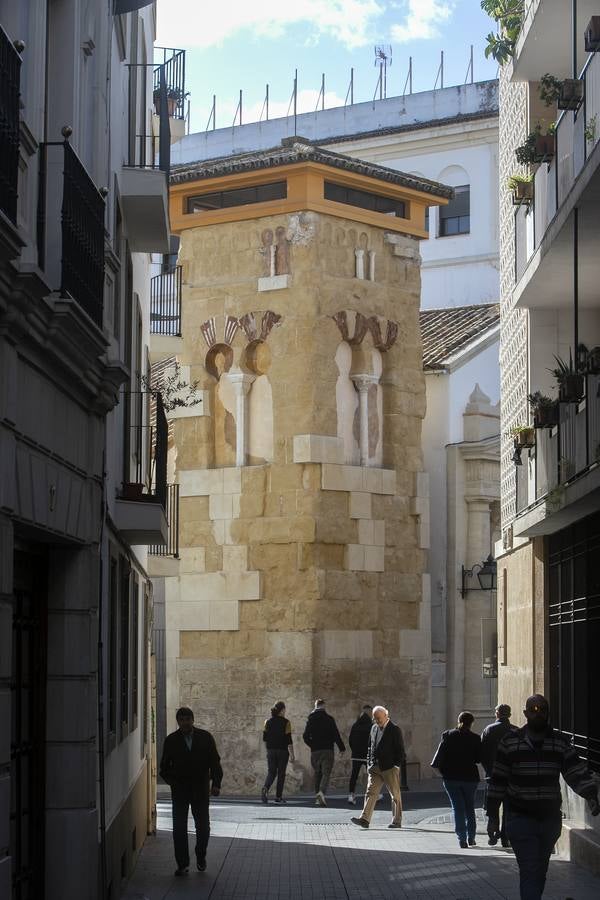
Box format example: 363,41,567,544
487,694,600,900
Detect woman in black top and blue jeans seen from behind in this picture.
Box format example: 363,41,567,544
431,712,481,849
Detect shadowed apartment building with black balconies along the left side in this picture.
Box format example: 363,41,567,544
0,0,185,900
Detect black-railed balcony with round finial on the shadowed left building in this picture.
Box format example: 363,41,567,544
38,141,104,328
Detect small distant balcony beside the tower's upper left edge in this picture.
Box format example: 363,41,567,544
150,266,182,363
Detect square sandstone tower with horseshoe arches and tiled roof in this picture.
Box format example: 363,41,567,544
155,139,452,793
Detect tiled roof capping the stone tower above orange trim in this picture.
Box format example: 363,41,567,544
171,137,454,200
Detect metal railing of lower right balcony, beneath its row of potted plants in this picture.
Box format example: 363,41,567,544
516,373,600,513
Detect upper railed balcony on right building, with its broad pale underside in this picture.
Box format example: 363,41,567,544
513,53,600,308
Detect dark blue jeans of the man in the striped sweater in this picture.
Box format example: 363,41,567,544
506,811,562,900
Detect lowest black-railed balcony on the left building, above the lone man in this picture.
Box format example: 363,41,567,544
115,393,168,545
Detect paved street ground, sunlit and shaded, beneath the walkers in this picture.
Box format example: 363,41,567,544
125,791,600,900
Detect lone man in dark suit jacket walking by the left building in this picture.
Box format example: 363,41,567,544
160,706,223,875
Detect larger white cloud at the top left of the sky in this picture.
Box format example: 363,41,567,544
157,0,384,48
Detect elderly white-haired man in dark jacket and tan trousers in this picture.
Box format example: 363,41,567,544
352,706,406,828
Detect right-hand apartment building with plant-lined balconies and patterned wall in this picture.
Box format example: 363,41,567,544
496,0,600,866
